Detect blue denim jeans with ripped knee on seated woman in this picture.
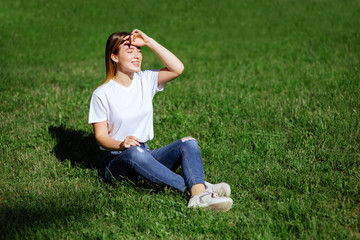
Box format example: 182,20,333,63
103,137,205,192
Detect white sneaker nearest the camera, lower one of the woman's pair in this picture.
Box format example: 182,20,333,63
187,190,233,212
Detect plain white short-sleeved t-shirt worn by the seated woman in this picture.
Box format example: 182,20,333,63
89,70,164,150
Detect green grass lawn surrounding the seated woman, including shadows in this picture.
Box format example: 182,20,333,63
0,0,360,239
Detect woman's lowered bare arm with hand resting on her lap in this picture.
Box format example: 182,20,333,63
93,121,140,151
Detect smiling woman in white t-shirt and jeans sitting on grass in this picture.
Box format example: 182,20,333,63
89,29,233,211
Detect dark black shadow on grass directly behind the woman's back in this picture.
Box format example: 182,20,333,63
49,125,102,174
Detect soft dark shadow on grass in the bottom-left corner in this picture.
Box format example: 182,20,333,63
0,191,97,239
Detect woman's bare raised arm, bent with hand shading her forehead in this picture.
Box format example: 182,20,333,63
131,29,184,85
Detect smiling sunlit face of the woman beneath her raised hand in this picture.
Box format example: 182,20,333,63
115,41,142,73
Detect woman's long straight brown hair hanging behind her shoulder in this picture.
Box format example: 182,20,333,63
103,32,131,84
